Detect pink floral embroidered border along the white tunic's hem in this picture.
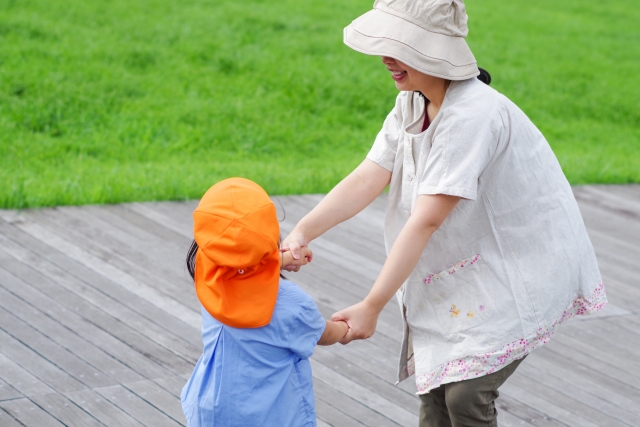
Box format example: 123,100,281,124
416,283,607,394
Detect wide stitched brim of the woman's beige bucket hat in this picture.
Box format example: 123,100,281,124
344,9,480,80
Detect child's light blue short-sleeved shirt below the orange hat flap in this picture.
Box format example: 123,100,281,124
181,279,326,427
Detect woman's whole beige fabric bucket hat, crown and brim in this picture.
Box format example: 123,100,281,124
344,0,479,80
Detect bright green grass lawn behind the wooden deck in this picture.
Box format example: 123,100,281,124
0,0,640,208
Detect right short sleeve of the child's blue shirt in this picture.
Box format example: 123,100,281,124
289,290,326,359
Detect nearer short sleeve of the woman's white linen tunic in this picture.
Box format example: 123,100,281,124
418,103,502,200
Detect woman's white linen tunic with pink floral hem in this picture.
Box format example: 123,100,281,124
367,78,606,394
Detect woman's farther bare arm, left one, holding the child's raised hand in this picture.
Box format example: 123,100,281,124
282,159,391,271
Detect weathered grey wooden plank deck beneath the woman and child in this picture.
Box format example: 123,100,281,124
0,186,640,427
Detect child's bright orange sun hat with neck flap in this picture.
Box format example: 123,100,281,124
193,178,280,328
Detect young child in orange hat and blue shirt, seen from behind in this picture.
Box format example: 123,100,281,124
181,178,348,427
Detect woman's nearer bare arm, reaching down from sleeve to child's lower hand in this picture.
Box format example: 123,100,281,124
331,194,460,344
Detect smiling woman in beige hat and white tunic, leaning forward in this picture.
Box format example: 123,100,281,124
283,0,606,426
